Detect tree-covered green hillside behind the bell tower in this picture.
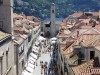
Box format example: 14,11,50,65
14,0,100,19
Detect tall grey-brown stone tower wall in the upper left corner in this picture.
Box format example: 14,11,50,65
0,0,13,34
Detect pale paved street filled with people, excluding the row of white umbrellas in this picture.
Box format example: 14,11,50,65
21,39,57,75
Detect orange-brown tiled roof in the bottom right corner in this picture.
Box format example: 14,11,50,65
72,60,100,75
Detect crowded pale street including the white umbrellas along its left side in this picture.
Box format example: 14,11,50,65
22,36,57,75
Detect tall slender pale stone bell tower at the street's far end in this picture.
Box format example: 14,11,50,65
50,3,56,37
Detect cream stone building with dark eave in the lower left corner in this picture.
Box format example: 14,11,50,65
0,34,16,75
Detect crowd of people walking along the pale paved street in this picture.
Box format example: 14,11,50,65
32,36,57,75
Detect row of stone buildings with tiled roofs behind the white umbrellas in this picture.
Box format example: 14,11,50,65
13,13,40,75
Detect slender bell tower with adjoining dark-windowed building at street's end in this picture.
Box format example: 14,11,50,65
43,3,59,37
